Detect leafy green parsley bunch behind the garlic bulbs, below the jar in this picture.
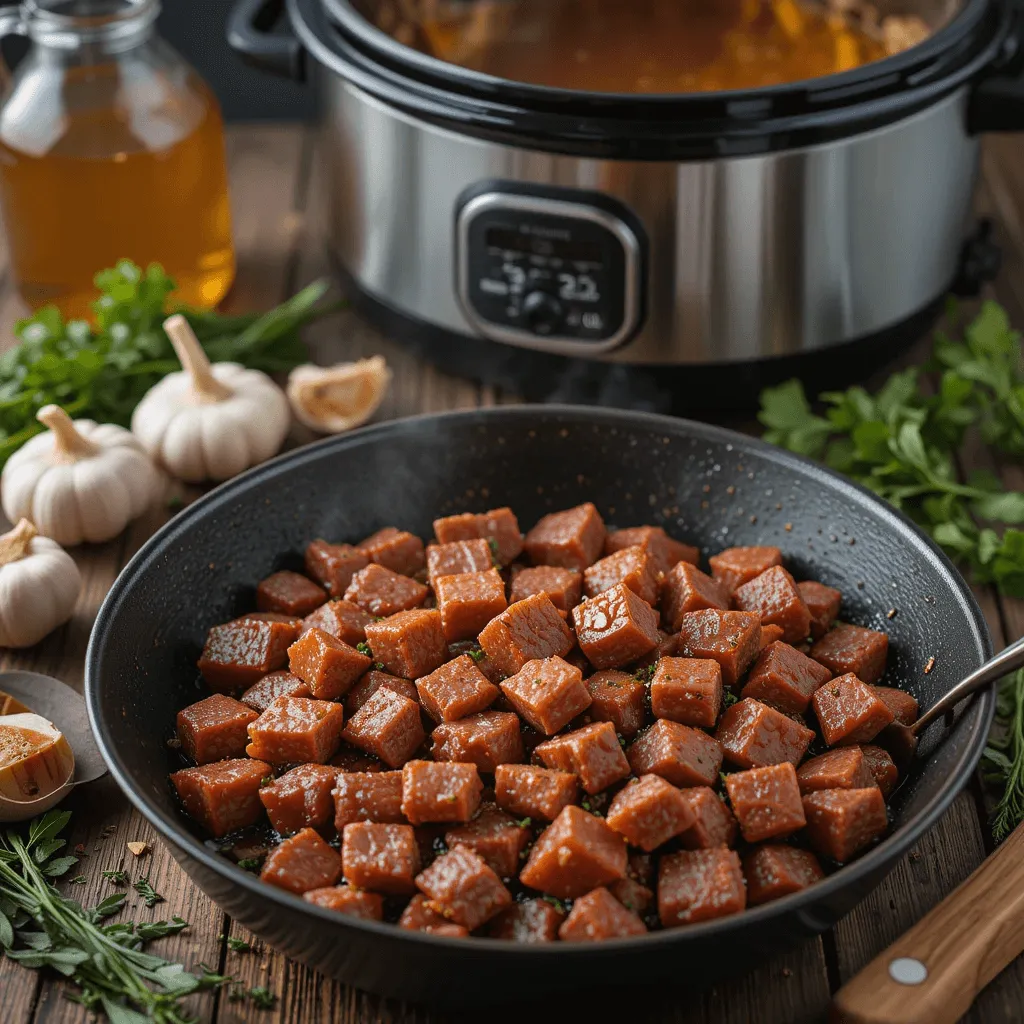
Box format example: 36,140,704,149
0,260,337,468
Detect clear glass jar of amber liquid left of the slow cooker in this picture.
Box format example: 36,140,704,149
0,0,234,316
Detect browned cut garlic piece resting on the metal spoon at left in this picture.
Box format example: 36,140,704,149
0,712,75,821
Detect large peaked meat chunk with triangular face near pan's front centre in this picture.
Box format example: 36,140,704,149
519,806,627,899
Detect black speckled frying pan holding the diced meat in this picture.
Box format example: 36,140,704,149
86,407,994,999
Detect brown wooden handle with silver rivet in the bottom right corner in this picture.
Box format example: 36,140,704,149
830,824,1024,1024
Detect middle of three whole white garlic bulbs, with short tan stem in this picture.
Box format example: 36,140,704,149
0,406,160,547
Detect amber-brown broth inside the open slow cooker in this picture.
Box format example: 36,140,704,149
354,0,935,93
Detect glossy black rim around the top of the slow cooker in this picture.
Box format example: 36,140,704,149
287,0,1014,160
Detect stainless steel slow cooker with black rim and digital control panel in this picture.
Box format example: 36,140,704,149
228,0,1024,407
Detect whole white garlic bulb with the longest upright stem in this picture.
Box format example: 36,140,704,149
131,314,291,483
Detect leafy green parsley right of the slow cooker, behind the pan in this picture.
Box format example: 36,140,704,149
759,302,1024,597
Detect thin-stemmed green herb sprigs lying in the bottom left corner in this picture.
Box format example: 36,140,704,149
0,811,230,1024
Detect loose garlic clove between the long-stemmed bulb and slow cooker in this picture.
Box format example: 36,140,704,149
288,355,391,434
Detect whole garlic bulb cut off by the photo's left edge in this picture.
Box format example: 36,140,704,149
0,519,82,647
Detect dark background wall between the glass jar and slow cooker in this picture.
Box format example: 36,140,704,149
160,0,312,121
